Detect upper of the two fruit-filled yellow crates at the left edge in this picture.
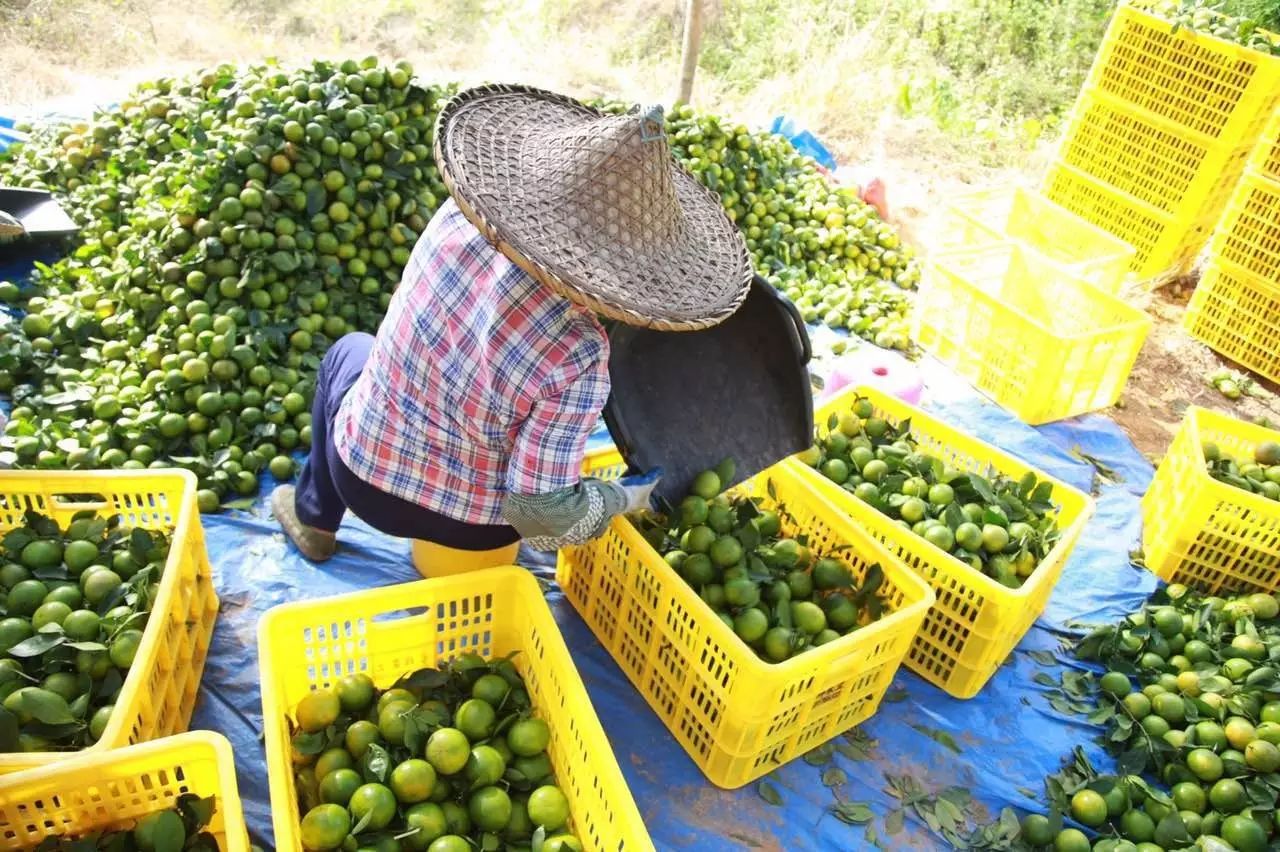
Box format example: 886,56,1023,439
0,469,218,774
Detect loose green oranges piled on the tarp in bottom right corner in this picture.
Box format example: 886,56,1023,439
1023,585,1280,852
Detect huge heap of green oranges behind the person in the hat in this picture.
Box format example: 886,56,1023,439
0,58,919,512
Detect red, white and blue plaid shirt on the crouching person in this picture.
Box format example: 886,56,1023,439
334,200,609,525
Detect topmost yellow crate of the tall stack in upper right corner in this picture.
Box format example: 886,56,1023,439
1087,0,1280,147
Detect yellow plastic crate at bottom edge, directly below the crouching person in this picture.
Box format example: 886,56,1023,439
257,567,654,852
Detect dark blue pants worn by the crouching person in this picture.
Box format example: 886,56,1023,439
294,333,520,550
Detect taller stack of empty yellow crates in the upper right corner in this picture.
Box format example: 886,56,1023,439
1044,0,1280,280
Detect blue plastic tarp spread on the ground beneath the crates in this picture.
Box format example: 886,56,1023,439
6,104,1156,851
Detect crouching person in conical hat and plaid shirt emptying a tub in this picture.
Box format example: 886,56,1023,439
271,86,751,562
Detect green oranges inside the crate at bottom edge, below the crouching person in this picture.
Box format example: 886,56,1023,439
292,656,582,852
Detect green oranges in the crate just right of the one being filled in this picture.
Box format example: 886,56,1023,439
799,398,1059,588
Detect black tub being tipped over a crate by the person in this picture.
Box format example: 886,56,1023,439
604,276,813,503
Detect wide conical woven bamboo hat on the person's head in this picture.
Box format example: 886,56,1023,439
435,86,751,331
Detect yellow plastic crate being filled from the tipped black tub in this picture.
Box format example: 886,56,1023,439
556,453,933,788
